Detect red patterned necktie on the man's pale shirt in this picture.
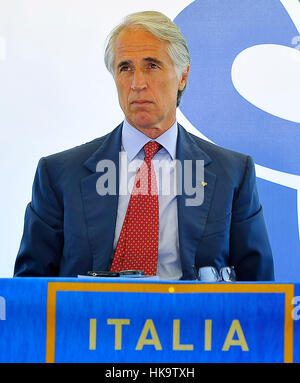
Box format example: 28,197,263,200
110,141,161,275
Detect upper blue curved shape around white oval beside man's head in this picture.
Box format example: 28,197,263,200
174,0,300,174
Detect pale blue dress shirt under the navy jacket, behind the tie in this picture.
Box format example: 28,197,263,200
114,119,182,280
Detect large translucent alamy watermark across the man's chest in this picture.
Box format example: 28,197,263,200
96,152,207,206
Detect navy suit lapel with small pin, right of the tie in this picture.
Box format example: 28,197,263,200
176,125,216,279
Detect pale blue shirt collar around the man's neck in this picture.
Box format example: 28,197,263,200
122,119,178,161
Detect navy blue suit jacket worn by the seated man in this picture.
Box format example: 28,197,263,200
14,124,274,281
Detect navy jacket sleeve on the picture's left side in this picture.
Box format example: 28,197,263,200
14,158,63,276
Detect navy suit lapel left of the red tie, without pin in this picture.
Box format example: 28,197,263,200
81,124,122,270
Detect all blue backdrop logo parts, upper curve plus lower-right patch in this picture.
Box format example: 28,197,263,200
174,0,300,281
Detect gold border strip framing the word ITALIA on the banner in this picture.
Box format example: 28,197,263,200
46,282,294,363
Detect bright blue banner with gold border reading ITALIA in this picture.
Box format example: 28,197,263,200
0,278,300,363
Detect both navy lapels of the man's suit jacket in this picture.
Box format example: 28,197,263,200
81,124,216,279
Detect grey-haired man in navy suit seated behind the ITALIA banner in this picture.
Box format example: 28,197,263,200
15,12,274,281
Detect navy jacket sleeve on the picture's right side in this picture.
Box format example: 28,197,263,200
230,157,274,281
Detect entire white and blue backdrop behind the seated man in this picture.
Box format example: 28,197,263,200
0,0,300,281
